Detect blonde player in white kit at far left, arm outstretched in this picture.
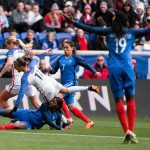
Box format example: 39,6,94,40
0,36,51,108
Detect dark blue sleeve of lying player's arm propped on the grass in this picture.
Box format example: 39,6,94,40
40,103,61,130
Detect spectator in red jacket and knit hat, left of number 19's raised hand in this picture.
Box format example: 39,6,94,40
44,3,62,31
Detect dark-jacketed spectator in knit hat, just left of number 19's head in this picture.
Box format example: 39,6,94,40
95,1,114,26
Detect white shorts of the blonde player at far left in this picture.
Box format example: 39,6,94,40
5,84,37,97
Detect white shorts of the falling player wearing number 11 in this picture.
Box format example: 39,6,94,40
43,77,63,101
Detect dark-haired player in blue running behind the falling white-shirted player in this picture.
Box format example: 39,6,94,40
50,41,100,128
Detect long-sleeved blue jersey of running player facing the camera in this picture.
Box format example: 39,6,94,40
50,55,96,85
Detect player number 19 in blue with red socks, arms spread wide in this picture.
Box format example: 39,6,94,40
64,12,150,143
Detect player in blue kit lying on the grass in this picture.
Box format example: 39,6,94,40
0,97,70,130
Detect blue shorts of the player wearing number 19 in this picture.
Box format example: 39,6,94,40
109,68,135,98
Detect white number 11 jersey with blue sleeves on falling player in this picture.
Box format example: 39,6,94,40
15,59,63,106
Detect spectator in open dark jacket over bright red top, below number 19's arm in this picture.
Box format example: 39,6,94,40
73,29,93,50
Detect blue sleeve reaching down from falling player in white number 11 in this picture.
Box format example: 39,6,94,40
15,72,30,107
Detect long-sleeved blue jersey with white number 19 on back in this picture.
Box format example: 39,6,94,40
74,22,150,68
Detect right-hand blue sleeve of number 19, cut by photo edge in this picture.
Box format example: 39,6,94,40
132,28,150,37
